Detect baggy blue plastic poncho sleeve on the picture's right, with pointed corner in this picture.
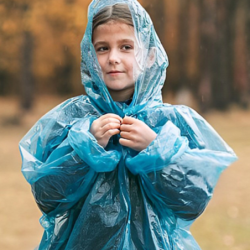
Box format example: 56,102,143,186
126,106,237,220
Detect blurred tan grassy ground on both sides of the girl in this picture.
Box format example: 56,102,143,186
0,94,250,250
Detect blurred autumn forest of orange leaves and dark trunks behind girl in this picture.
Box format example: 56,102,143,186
0,0,250,111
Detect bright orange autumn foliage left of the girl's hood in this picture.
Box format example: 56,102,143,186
0,0,90,82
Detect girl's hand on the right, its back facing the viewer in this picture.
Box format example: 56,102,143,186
119,116,157,151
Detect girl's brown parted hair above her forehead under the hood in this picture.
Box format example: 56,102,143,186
92,4,134,31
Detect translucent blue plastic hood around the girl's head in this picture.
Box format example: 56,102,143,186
81,0,168,116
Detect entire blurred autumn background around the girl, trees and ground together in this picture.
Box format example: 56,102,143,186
0,0,250,250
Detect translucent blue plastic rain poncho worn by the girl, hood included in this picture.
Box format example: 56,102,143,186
20,0,236,250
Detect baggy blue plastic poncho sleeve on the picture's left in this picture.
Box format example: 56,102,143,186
19,96,119,214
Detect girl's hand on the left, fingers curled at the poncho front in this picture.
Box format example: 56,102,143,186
90,114,122,148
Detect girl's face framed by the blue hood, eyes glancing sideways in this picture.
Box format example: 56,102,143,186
93,21,136,101
